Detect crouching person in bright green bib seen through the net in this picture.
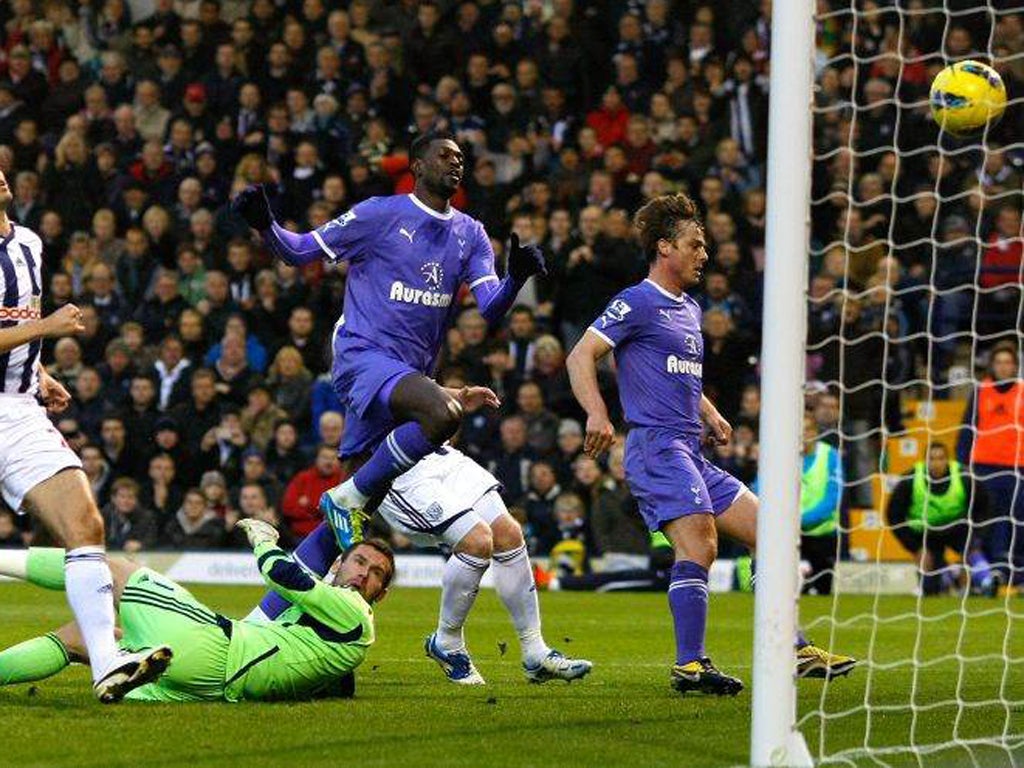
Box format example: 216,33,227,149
887,443,996,595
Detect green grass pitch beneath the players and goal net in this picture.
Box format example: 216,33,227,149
0,584,1024,768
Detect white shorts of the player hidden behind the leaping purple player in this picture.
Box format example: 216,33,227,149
378,445,506,547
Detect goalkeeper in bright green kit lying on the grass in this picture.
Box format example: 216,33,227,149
0,520,394,701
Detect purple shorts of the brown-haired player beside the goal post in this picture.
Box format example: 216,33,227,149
625,427,746,530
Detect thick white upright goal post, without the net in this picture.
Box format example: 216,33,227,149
751,0,814,768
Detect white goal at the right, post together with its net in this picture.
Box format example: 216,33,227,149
750,0,1024,768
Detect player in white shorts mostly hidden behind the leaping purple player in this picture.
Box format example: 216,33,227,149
250,421,593,685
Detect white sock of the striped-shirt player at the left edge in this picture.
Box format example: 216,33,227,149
65,546,118,682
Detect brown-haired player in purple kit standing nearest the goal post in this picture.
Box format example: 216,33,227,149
566,194,856,695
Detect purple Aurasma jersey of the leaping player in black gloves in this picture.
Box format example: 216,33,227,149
313,195,498,374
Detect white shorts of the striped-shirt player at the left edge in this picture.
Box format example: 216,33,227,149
0,395,82,513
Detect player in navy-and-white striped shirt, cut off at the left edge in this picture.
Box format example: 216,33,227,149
0,172,167,703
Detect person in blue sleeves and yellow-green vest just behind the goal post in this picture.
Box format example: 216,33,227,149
800,411,843,595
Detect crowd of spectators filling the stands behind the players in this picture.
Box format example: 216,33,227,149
0,0,1024,573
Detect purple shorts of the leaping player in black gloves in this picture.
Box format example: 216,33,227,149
332,339,422,459
